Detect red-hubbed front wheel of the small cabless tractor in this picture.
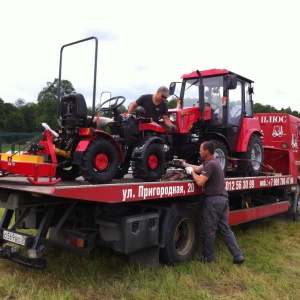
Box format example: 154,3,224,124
132,144,165,181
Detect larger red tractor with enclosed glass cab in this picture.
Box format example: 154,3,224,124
164,69,264,176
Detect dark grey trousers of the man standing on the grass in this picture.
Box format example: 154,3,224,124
202,196,242,261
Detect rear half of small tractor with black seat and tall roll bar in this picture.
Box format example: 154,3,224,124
33,37,125,183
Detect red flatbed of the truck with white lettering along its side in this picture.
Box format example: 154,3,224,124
0,174,297,203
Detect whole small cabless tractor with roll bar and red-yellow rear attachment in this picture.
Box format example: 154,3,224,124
0,37,171,185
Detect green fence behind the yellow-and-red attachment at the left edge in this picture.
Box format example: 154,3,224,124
0,131,41,153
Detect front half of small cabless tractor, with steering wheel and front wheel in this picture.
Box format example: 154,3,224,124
97,96,173,181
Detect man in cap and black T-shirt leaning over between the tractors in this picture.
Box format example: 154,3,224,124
128,86,177,130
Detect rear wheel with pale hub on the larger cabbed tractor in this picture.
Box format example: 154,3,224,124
238,134,264,176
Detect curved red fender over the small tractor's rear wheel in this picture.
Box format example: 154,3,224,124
73,130,124,165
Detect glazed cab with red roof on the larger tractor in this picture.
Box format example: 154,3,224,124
170,69,253,131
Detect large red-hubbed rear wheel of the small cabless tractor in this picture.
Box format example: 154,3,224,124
81,139,119,184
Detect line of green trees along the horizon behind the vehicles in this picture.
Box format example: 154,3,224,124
0,78,300,132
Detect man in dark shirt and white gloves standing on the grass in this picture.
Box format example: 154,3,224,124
184,141,244,264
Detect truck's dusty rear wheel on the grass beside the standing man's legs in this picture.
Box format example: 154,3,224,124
160,209,200,265
